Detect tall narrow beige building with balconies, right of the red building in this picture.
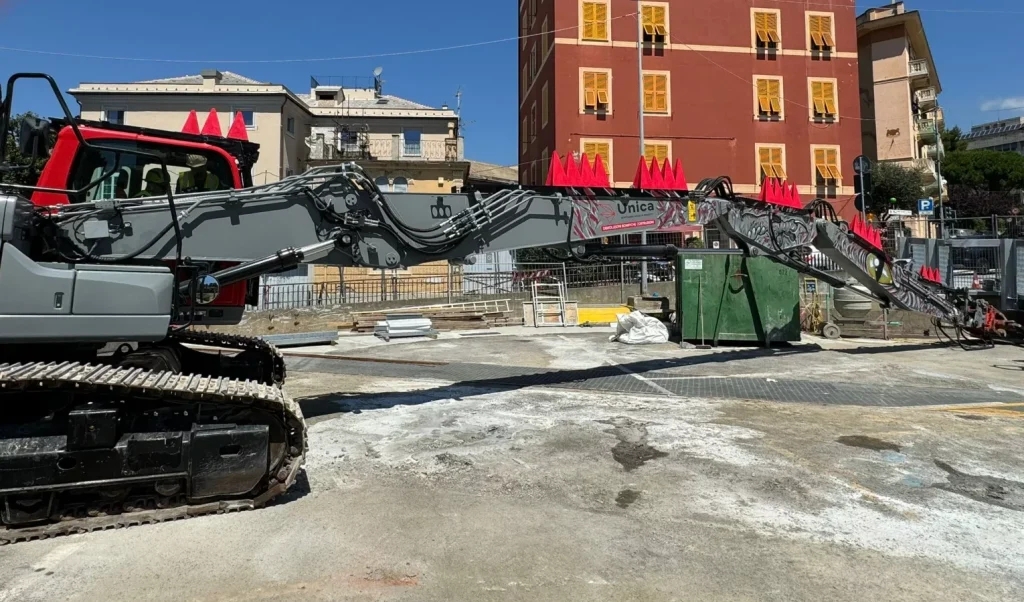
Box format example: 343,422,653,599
857,2,944,187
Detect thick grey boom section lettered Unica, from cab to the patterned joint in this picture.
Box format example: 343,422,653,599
51,164,685,268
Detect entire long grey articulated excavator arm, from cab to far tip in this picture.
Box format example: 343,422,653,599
41,164,1019,344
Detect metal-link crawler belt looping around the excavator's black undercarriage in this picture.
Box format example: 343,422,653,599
0,360,307,545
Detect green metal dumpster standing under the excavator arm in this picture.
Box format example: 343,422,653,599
676,250,800,345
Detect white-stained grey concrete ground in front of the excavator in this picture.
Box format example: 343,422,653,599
0,333,1024,601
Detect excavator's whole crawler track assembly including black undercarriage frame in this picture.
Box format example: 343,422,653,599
0,362,307,545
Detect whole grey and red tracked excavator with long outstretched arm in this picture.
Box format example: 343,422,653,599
0,74,1024,543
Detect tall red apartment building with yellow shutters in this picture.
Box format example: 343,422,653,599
519,0,861,215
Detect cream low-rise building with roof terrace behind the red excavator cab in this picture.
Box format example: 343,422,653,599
69,70,469,192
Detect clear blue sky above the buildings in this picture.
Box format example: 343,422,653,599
0,0,1024,165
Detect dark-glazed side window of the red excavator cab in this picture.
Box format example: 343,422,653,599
69,140,232,203
